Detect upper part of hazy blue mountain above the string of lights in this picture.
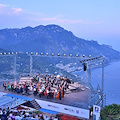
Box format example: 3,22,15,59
0,25,120,60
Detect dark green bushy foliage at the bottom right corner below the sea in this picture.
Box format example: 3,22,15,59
101,104,120,120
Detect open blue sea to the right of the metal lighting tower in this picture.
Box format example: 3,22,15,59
101,61,120,105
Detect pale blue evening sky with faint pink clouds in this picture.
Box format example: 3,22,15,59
0,0,120,51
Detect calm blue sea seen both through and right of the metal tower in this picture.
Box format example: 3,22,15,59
74,61,120,105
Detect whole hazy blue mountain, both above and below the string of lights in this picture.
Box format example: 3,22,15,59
0,25,120,79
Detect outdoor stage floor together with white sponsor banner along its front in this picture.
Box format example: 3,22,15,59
0,82,89,119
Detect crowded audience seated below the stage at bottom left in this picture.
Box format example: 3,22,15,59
0,108,58,120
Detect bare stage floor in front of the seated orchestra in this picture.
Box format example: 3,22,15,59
0,87,89,109
